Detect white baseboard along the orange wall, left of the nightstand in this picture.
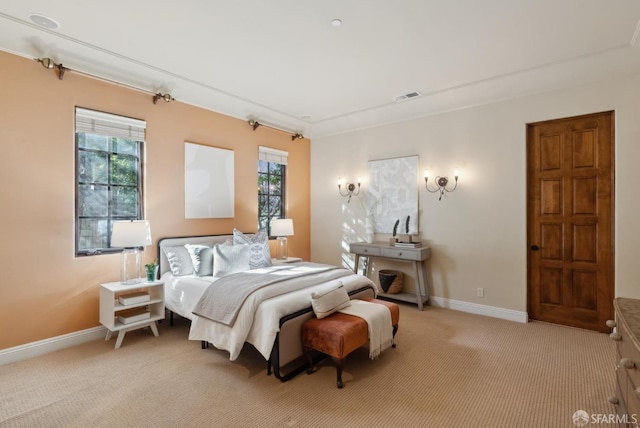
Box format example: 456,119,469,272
0,327,107,366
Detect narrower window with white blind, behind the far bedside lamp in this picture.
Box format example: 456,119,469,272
258,146,289,236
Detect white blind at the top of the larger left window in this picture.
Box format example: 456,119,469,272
76,107,147,141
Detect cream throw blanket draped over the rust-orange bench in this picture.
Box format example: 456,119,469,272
338,299,393,359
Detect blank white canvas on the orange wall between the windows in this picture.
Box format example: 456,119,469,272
184,142,235,219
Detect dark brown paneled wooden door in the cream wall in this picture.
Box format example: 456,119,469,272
527,112,614,332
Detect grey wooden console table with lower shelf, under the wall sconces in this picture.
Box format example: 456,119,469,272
349,242,431,310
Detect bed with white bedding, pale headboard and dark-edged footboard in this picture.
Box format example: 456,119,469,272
158,231,377,382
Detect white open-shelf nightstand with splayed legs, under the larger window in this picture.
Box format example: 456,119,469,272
100,281,164,349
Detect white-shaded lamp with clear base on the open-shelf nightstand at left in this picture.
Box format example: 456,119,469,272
111,220,151,284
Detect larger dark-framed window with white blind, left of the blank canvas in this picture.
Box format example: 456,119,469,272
75,108,146,256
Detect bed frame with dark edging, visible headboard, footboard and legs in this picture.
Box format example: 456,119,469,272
158,235,375,382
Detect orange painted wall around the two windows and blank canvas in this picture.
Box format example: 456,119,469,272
0,52,310,349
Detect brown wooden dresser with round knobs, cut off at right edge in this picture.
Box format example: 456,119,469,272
607,297,640,427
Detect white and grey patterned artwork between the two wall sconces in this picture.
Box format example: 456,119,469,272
367,155,418,235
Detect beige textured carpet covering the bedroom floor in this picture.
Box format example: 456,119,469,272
0,305,615,428
